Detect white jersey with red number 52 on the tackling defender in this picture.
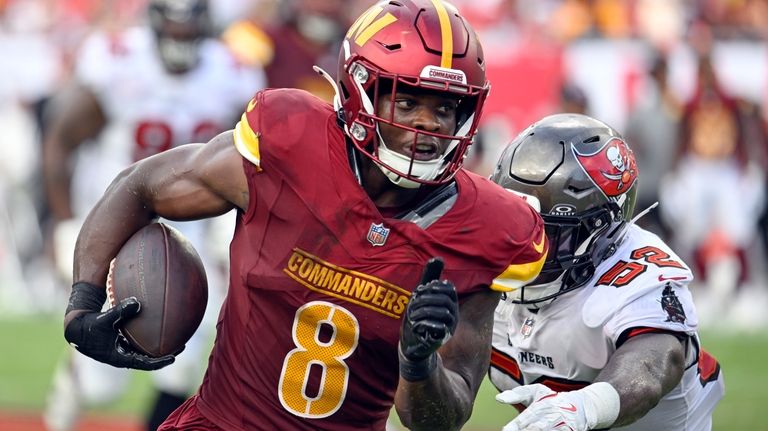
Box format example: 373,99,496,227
489,225,724,431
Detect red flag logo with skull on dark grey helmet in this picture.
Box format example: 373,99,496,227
574,138,637,197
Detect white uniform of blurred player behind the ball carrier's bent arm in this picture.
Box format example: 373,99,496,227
45,24,265,431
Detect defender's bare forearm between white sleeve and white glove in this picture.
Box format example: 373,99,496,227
596,334,684,426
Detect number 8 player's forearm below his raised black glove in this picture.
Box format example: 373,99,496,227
395,356,475,430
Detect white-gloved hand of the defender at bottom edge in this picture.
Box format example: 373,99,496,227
496,382,619,431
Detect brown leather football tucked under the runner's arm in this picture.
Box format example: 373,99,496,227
107,223,208,357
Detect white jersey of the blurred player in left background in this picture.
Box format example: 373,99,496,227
72,27,265,218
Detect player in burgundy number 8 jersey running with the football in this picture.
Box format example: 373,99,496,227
65,0,547,430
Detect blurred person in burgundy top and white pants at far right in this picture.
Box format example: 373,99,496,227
659,52,765,322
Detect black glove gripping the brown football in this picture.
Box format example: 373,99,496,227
64,282,175,370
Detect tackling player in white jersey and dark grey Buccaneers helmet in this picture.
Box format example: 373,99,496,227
489,114,724,431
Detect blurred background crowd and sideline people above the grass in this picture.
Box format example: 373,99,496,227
0,0,768,348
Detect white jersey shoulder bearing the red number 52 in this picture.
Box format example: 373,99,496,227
582,225,693,328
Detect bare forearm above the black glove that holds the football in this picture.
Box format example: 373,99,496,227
73,168,156,286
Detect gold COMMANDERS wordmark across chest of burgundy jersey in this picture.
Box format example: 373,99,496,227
283,248,411,319
